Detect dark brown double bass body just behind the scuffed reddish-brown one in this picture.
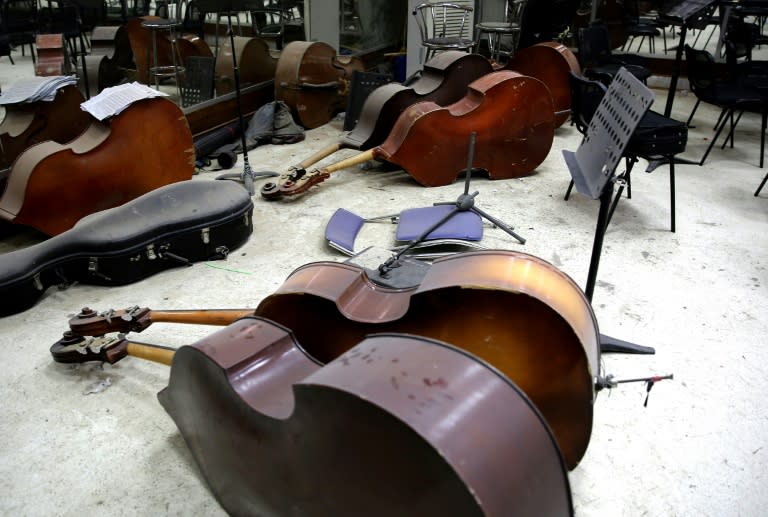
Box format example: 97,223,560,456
342,50,493,151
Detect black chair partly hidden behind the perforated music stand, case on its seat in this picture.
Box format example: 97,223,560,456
565,72,688,232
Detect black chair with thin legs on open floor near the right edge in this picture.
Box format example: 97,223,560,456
685,45,768,168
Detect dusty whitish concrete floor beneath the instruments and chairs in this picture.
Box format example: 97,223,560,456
0,38,768,517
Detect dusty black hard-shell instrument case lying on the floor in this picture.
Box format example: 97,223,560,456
0,180,253,316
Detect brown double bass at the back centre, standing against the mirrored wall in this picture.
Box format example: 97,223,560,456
275,41,365,129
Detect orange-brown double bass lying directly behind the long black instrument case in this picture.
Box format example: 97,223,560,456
0,98,195,235
